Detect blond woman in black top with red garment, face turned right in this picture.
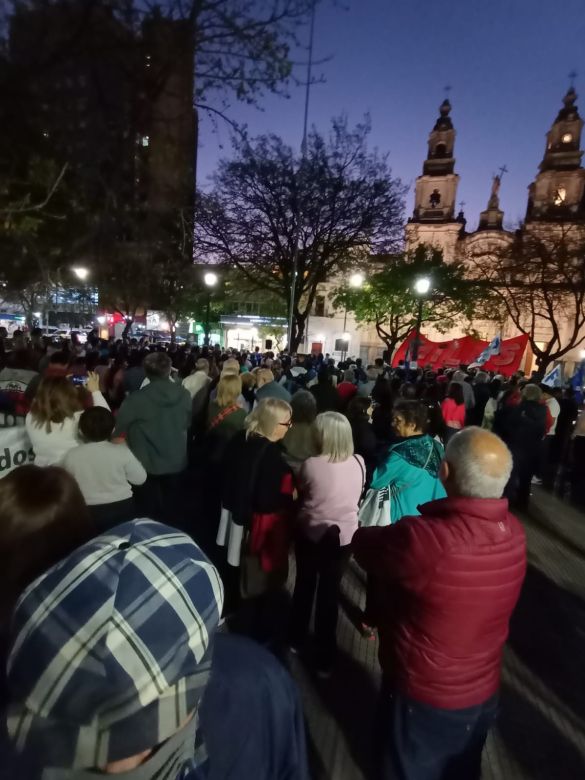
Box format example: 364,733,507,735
217,398,294,642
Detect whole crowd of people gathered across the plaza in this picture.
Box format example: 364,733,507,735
0,331,585,780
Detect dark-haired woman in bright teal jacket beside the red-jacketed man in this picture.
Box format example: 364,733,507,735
370,401,446,523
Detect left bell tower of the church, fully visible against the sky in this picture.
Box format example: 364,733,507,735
406,100,465,260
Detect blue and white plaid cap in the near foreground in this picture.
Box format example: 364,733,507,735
8,520,223,769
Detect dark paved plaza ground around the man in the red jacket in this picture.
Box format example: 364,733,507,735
291,488,585,780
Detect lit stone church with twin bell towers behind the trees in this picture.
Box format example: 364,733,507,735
405,87,585,371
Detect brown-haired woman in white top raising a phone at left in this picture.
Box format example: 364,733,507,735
26,373,110,466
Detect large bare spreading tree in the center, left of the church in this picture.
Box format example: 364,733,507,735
196,118,404,350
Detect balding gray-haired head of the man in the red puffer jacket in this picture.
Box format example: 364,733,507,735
445,426,512,498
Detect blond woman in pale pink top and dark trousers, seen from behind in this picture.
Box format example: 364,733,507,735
290,412,365,677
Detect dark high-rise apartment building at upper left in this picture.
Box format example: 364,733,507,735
9,0,196,212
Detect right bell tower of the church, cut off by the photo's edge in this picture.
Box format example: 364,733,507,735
526,87,585,223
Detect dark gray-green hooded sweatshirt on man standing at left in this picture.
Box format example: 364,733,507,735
115,377,191,475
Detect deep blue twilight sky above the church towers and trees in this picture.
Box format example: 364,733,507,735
198,0,585,230
